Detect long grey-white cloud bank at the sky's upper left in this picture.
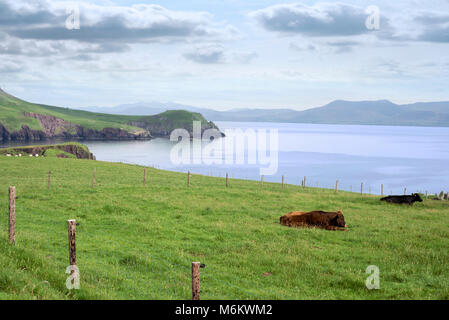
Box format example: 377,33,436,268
0,1,239,43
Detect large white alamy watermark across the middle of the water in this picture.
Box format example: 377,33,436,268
170,121,279,176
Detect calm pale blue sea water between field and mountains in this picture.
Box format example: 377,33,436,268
3,121,449,194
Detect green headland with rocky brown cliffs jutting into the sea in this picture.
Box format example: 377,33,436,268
0,89,220,142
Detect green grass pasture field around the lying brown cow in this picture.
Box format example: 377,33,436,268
0,156,449,299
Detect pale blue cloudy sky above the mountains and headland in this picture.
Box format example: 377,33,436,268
0,0,449,110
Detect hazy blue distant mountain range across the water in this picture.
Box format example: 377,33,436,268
79,100,449,127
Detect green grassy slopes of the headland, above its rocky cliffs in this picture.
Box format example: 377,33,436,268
0,89,219,138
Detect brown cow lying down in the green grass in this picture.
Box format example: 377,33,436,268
280,211,346,230
